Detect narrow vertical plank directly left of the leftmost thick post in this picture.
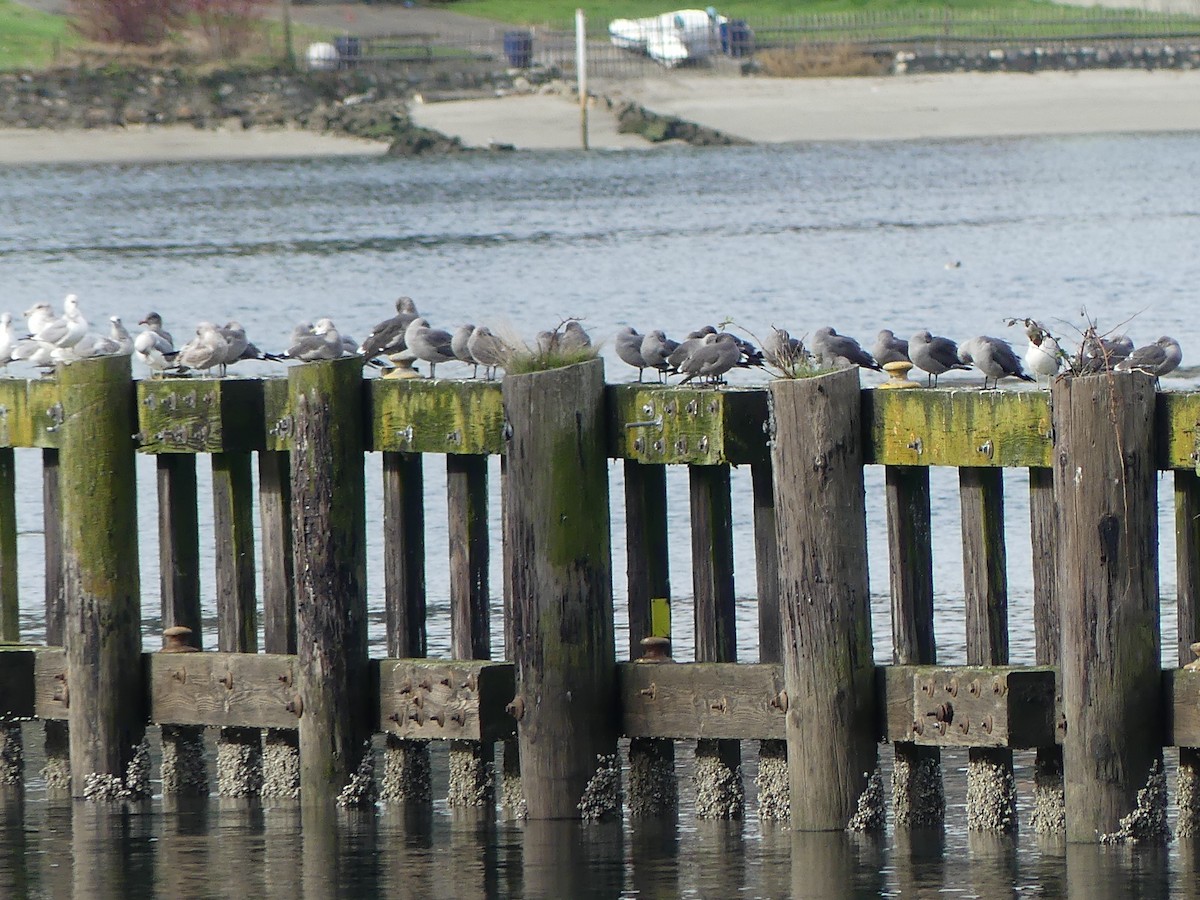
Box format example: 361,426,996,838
42,449,71,797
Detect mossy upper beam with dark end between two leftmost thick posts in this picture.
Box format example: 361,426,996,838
137,378,267,454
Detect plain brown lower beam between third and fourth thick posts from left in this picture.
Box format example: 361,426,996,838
617,662,786,740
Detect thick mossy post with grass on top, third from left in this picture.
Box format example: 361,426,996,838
503,360,617,818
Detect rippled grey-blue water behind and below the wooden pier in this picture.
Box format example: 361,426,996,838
0,134,1200,896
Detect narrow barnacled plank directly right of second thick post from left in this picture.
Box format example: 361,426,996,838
380,452,433,804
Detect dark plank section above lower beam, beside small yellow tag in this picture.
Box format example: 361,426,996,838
624,460,671,659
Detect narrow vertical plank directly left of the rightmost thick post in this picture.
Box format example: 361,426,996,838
1030,468,1067,834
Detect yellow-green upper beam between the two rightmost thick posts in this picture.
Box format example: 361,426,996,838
863,389,1052,467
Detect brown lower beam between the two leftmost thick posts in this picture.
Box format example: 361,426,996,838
146,653,299,728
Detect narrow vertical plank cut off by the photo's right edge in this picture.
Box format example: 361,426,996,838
1175,469,1200,839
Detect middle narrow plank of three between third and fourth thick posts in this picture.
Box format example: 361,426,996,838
688,466,745,818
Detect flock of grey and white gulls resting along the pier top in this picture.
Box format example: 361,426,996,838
0,294,1182,389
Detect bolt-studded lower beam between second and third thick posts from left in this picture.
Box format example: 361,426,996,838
376,659,516,743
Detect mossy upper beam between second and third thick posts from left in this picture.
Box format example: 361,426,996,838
367,378,504,454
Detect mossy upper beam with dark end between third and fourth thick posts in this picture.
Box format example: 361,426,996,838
607,384,767,466
